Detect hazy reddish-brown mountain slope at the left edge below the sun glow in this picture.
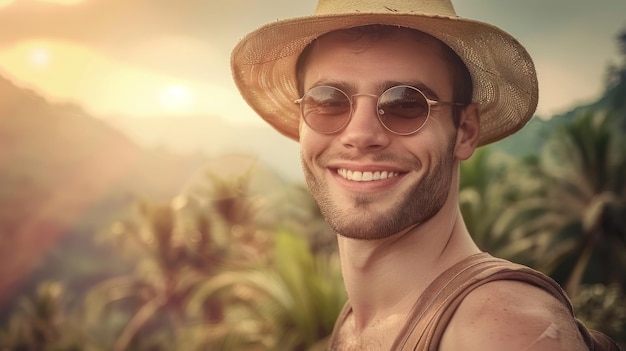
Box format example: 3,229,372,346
0,77,207,310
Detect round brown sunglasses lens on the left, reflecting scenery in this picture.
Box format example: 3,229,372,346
300,86,351,134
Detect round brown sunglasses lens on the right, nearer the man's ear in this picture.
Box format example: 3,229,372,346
378,86,430,134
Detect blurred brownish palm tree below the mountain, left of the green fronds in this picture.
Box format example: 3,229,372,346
86,188,252,351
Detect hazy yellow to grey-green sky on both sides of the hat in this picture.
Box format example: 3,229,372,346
0,0,626,122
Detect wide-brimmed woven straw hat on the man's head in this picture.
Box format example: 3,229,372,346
231,0,538,145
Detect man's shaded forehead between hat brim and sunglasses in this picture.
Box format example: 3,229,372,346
299,27,451,93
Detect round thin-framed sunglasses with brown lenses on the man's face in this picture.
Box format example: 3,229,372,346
294,85,464,135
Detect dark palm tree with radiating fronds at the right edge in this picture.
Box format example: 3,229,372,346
500,112,626,296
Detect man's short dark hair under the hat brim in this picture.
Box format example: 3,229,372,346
296,24,474,127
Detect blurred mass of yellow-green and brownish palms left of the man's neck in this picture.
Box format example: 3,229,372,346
61,163,345,351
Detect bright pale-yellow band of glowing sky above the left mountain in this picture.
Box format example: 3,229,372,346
0,38,260,120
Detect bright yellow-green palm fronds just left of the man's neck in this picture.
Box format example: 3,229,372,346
189,232,346,350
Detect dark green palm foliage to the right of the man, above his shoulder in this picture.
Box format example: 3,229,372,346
460,85,626,341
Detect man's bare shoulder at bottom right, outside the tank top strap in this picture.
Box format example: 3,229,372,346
439,281,587,351
